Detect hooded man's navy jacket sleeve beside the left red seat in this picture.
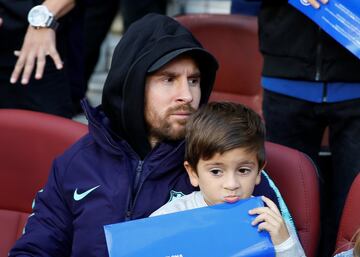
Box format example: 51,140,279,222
9,160,72,257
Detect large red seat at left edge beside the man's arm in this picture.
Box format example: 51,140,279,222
0,109,87,257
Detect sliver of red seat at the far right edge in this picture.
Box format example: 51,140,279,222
335,173,360,253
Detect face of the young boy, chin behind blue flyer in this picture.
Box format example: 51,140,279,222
185,148,262,205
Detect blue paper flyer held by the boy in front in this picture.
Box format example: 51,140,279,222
104,197,275,257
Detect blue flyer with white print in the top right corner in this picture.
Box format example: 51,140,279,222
289,0,360,59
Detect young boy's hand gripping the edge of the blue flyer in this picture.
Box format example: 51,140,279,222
249,196,290,245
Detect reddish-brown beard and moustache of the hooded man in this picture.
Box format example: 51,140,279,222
149,104,196,141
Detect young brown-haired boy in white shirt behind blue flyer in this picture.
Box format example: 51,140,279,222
151,102,305,257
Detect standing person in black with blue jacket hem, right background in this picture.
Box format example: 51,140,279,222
253,0,360,254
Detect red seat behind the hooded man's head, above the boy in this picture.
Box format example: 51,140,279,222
176,14,263,114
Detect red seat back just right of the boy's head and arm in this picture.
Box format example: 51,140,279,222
265,142,320,257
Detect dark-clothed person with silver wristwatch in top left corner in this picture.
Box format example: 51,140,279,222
0,0,75,118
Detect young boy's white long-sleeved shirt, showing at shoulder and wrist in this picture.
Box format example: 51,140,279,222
150,191,305,257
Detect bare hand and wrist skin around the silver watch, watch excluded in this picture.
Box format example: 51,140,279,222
10,0,75,85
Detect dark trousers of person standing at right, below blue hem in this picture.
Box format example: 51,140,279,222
263,90,360,256
